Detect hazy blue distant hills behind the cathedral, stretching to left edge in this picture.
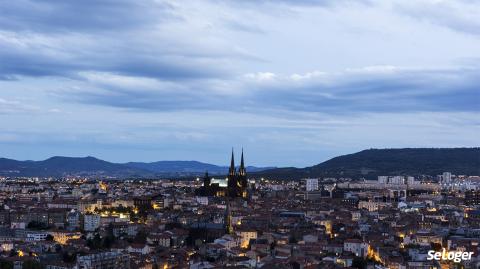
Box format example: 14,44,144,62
0,156,272,178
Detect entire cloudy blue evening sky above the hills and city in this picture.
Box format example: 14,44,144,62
0,0,480,167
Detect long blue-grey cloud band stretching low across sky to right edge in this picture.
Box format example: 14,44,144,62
62,66,480,114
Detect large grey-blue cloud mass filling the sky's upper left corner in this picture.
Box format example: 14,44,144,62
0,0,259,80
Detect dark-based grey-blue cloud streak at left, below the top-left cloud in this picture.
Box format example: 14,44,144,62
0,32,234,80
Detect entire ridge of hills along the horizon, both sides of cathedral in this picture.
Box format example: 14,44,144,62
0,147,480,179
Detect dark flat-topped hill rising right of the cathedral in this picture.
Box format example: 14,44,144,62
255,148,480,179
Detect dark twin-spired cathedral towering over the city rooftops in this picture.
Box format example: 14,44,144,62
196,149,248,199
